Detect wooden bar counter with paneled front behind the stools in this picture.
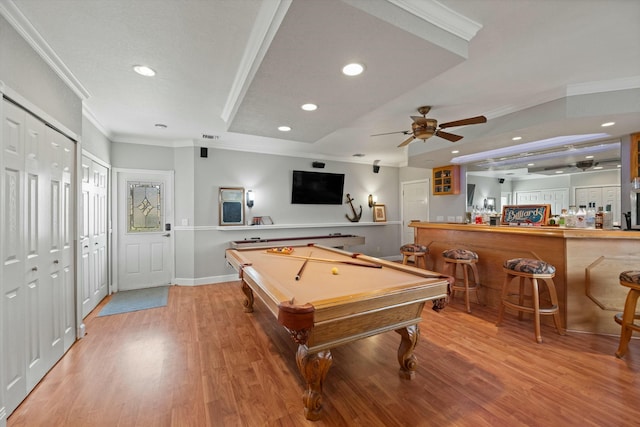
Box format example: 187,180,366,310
409,222,640,335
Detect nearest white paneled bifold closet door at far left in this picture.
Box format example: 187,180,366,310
0,101,76,414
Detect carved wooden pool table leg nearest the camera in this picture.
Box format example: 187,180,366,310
296,344,333,421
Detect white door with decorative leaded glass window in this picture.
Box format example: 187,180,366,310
117,171,174,290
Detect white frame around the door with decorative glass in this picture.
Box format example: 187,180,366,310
108,168,176,295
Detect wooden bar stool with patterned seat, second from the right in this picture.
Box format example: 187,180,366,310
497,258,564,343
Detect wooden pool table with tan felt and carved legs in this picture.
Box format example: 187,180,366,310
226,245,452,420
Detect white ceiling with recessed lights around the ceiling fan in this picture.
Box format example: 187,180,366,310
0,0,640,177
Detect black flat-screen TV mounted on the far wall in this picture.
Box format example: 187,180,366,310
291,171,344,205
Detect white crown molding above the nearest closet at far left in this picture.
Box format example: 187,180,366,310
0,0,91,100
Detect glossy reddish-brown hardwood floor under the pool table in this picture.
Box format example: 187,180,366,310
8,282,640,427
